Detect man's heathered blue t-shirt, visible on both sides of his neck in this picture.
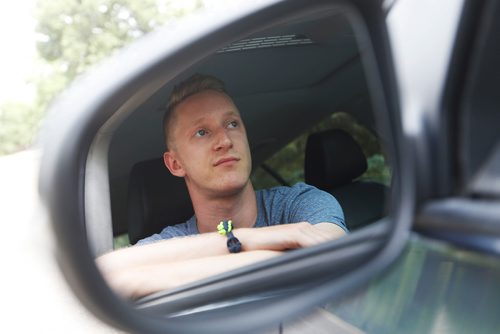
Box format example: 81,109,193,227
137,182,347,245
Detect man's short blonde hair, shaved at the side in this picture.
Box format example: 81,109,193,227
163,73,229,150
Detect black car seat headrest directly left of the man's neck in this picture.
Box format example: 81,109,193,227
127,158,193,244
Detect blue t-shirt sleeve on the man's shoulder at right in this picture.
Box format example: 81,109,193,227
288,183,348,232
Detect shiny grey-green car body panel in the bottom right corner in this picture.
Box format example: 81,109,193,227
325,234,500,333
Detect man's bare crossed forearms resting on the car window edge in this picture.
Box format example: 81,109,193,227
96,223,345,298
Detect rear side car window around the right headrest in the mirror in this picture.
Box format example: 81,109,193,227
252,112,391,189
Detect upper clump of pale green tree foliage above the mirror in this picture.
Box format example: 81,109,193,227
37,0,201,81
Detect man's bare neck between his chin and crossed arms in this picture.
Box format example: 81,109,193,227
191,182,257,233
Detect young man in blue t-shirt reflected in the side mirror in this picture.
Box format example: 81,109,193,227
97,75,347,298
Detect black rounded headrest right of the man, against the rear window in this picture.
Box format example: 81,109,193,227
304,129,367,189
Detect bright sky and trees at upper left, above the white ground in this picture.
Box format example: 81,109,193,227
0,0,230,156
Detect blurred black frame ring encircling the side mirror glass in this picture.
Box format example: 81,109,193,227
40,0,415,333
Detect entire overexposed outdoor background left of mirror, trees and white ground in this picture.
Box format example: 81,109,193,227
0,0,240,333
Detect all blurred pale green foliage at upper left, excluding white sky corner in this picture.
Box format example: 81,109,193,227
0,0,204,155
